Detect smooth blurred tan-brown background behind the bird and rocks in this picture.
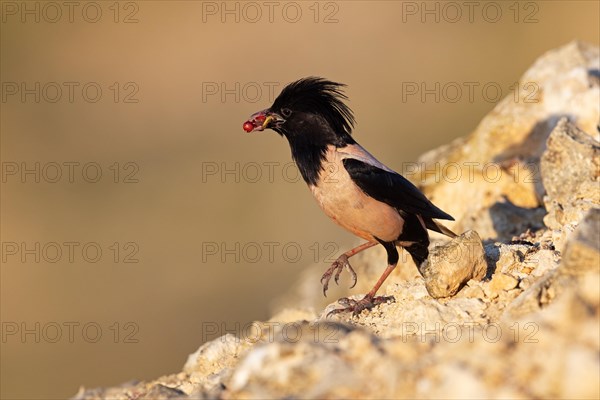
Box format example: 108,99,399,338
0,1,600,399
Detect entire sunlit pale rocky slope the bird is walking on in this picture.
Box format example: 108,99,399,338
75,42,600,399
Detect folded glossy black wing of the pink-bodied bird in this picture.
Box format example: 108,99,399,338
342,158,454,221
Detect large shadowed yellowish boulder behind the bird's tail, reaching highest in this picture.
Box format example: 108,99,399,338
418,42,600,241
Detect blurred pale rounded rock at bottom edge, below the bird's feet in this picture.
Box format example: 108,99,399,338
226,322,405,398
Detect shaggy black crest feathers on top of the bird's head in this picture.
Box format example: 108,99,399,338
271,77,354,136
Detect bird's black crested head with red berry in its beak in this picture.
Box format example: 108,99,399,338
243,77,354,145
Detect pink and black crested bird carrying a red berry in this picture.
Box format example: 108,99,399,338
243,76,457,315
